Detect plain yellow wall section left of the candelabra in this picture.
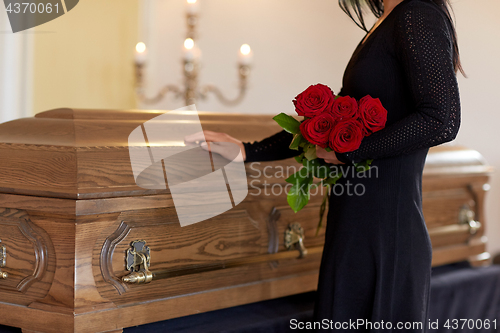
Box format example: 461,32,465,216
31,0,139,113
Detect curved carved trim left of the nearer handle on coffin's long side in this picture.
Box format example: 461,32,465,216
99,221,132,295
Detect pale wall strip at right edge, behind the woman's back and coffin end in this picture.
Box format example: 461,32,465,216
454,0,500,253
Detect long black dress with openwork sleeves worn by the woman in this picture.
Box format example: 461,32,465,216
245,0,460,332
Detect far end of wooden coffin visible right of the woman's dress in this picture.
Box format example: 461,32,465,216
422,145,492,266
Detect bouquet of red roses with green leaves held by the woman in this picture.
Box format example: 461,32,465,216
273,84,387,231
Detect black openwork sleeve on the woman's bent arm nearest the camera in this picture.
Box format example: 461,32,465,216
337,1,460,162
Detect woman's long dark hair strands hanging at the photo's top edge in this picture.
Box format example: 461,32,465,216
339,0,465,76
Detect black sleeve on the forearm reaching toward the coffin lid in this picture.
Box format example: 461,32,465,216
243,130,301,162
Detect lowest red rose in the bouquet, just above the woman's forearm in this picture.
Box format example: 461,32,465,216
329,119,364,153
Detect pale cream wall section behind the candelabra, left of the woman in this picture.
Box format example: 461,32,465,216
139,0,363,114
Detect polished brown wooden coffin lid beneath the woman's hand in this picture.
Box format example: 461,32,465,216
0,108,491,199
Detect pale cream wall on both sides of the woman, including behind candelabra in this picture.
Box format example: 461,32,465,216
142,0,500,253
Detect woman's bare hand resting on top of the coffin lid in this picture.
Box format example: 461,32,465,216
184,131,246,162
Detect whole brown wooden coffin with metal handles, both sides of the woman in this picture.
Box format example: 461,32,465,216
0,109,490,332
